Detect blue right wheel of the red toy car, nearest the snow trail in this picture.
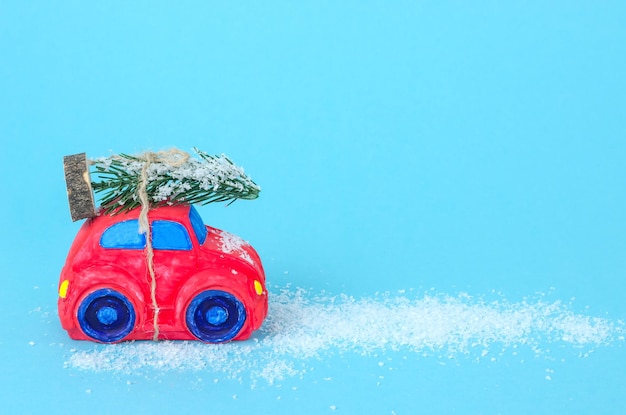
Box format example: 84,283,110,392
185,290,246,343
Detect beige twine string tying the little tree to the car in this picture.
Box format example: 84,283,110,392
137,149,189,341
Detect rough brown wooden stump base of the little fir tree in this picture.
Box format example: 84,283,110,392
63,153,97,221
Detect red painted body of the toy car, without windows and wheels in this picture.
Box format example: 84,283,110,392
58,205,267,341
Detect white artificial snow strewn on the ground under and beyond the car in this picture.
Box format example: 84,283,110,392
66,289,624,384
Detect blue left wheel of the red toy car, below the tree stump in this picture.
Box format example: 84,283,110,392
77,288,136,343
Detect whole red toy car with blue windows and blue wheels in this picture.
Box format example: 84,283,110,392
58,205,267,343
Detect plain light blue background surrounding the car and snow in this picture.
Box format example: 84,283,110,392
0,0,626,414
